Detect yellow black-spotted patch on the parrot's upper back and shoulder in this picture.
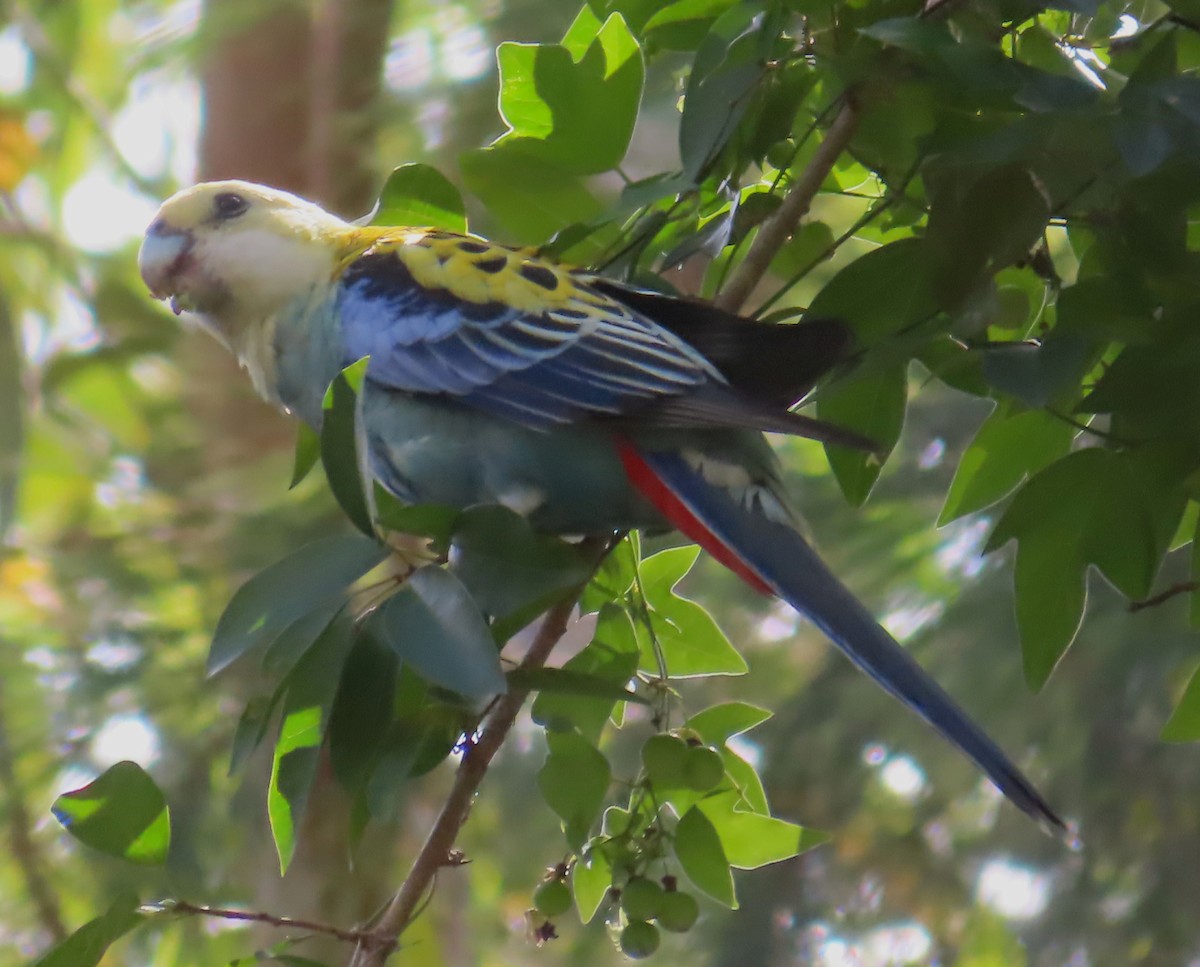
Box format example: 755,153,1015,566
338,228,629,316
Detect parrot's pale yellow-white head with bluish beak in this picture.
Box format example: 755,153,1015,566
138,181,349,344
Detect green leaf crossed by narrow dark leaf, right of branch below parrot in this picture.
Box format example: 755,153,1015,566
530,603,640,744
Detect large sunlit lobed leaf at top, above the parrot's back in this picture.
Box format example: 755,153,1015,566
497,8,644,175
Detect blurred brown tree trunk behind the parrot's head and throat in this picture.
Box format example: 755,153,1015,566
185,0,392,472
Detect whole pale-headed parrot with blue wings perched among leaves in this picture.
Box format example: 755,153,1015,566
138,181,1066,834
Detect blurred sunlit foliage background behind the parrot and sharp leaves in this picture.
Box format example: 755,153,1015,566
0,0,1200,967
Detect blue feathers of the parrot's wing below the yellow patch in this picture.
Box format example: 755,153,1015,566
337,250,724,428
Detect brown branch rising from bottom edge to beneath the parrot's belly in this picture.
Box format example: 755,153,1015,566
349,540,610,967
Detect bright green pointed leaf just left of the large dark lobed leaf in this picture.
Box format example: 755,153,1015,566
937,408,1079,527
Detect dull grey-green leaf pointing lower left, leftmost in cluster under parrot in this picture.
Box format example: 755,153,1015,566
205,534,388,675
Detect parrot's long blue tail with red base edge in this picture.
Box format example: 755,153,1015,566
622,448,1067,835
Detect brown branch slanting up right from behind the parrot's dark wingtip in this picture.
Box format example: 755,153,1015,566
713,97,858,312
